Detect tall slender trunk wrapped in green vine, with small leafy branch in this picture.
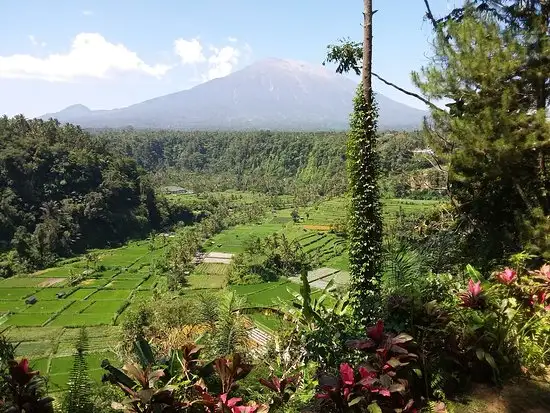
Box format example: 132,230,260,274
327,0,382,320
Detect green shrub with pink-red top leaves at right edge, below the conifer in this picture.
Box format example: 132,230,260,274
453,264,550,378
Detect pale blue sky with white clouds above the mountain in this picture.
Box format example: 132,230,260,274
0,0,458,116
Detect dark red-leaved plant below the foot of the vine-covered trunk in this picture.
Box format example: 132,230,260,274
316,320,418,412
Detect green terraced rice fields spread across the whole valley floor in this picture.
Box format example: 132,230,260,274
0,194,435,390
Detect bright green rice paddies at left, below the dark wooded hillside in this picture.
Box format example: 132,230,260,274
0,241,168,390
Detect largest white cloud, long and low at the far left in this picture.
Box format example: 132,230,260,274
0,33,172,82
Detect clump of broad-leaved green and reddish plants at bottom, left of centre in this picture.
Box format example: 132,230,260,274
102,340,267,413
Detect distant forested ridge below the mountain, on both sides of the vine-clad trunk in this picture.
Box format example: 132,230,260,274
100,129,442,197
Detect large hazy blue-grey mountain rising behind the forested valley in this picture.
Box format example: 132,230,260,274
42,59,427,130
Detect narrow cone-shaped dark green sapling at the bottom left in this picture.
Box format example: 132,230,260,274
62,328,95,413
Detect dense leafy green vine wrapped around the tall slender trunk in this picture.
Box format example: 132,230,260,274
348,85,382,319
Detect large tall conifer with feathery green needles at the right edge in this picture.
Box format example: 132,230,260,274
413,0,550,259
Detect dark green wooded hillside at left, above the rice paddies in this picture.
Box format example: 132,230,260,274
0,116,193,270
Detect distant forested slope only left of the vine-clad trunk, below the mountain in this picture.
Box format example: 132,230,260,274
106,130,346,199
